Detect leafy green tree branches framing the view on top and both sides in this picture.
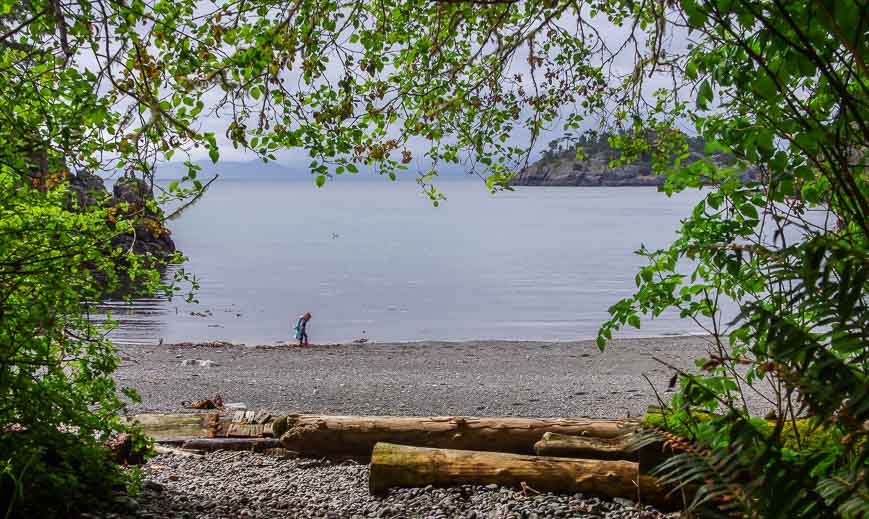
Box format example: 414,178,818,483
0,0,869,517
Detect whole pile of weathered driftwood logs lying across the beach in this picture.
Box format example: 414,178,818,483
130,411,681,508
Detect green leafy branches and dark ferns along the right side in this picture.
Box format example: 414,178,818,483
598,0,869,518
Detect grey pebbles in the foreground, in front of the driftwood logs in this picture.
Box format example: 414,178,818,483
85,452,669,519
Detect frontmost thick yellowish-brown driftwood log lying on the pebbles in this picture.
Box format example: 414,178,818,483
368,443,678,508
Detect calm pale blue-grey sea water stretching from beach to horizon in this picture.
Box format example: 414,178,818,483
105,179,701,344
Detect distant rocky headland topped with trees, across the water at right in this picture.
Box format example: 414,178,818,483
511,134,756,186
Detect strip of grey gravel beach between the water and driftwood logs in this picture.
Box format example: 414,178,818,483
115,336,760,418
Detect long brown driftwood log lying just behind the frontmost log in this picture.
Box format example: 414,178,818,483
275,415,639,457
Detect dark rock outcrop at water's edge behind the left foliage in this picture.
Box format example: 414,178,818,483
69,172,176,259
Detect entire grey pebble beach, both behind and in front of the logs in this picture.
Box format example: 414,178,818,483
91,337,728,519
